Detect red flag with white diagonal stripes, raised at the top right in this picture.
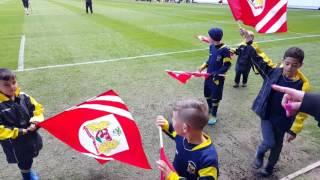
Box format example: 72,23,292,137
228,0,288,33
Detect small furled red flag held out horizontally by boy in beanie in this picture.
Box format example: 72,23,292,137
166,70,210,84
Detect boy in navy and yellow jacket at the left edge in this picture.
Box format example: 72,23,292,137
0,68,44,180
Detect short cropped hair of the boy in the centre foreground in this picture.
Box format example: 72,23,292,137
173,99,209,130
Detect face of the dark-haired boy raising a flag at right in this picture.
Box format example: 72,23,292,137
283,57,302,78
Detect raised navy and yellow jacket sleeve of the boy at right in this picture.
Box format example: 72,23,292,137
247,43,276,79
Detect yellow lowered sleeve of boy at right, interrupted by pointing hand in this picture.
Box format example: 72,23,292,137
290,70,310,134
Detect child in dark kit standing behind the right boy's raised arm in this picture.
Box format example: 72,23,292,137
233,28,254,88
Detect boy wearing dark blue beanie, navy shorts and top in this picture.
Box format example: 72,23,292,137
199,28,231,125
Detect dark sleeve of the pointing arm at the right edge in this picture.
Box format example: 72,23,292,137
300,93,320,121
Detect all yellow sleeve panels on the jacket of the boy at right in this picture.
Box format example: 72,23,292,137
252,43,311,134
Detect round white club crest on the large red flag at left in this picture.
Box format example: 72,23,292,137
79,114,129,156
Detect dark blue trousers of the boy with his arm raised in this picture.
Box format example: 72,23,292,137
257,120,285,168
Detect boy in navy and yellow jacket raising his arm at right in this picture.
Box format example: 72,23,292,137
248,46,310,176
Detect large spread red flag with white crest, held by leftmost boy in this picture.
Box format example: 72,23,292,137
39,90,151,169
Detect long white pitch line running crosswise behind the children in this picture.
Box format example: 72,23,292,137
18,34,320,71
